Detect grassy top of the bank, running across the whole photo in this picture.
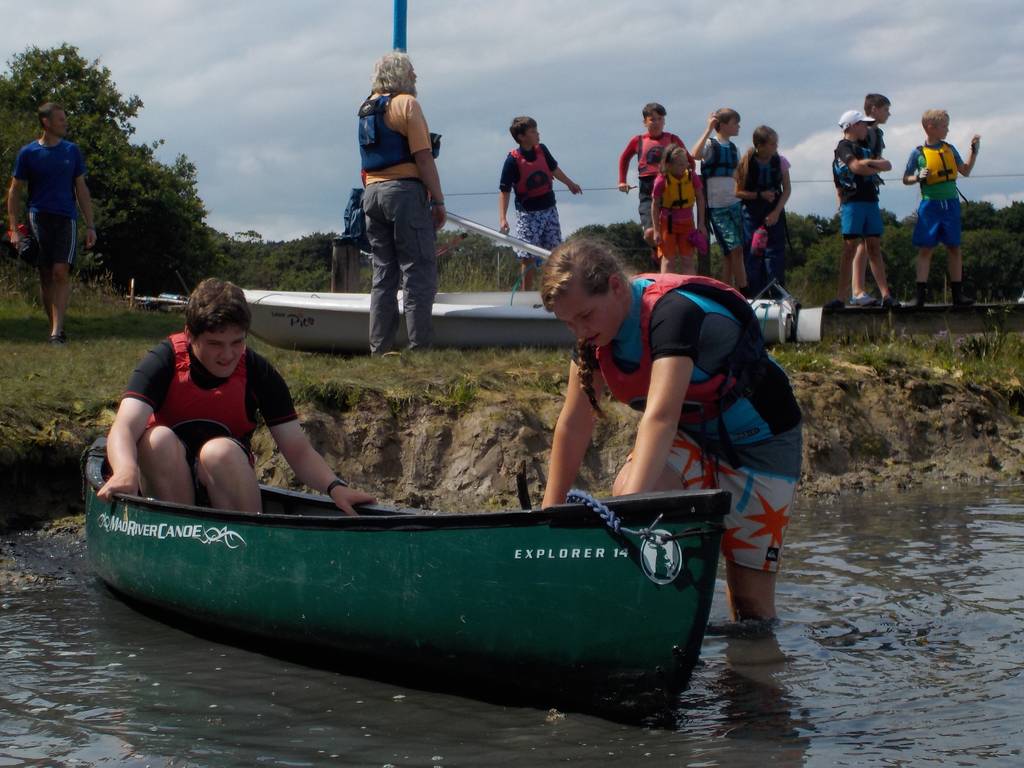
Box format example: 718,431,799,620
0,263,1024,464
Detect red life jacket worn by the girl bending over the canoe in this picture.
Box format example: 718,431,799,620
597,274,767,424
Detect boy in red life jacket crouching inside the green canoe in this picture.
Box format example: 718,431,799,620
97,278,375,515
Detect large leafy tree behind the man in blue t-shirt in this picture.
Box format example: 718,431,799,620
0,43,214,292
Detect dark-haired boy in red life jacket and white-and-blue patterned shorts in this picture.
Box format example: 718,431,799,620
498,116,583,291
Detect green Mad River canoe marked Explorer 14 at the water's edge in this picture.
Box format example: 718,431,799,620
83,440,729,719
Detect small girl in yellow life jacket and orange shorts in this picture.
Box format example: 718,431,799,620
650,144,708,274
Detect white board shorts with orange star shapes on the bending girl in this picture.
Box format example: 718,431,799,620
669,430,799,572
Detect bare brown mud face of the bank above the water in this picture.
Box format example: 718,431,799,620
0,362,1024,529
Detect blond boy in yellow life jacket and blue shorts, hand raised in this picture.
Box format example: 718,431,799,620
903,110,981,307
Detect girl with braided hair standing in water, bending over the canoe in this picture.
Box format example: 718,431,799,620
541,239,802,620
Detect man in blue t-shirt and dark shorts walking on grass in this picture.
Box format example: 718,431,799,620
7,101,96,345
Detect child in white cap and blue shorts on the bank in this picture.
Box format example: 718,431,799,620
827,110,899,309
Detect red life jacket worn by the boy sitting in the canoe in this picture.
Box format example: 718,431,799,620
146,332,256,439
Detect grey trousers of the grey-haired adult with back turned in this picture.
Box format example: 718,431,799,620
362,179,437,354
